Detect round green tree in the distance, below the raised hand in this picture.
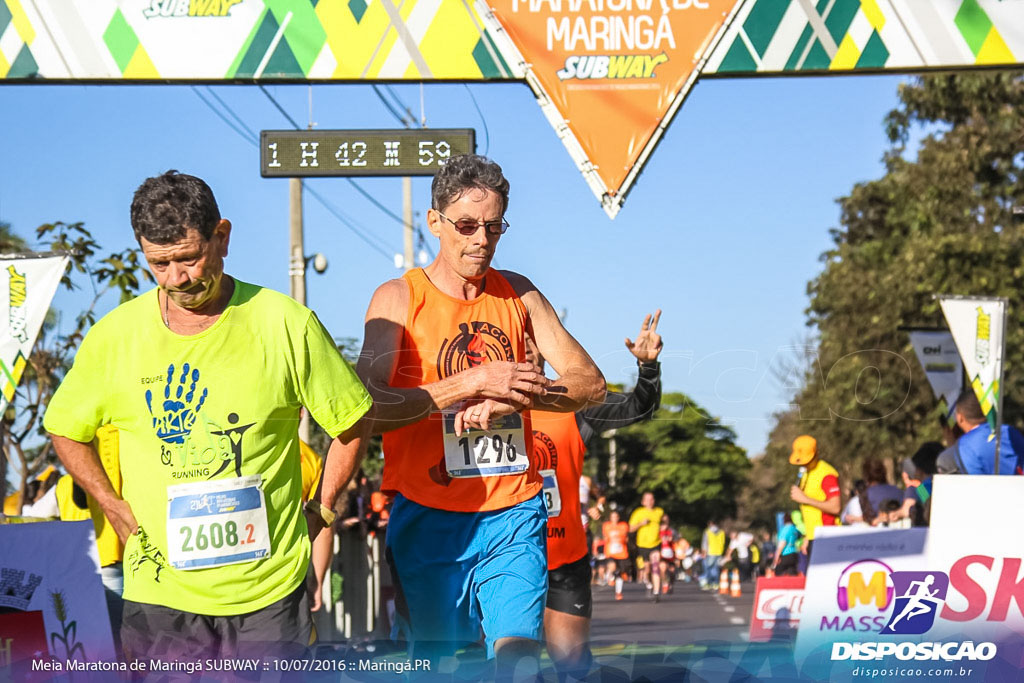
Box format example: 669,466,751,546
610,393,750,527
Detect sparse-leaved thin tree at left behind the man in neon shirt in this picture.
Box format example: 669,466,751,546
0,221,153,511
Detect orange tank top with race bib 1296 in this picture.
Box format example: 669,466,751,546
381,268,541,512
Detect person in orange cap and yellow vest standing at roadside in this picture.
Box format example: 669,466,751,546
790,434,840,562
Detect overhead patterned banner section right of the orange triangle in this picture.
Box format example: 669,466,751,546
705,0,1024,76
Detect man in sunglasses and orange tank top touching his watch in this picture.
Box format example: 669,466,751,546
357,155,605,675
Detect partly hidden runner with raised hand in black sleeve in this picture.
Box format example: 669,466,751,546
526,310,663,679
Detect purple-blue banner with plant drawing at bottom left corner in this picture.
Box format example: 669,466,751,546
0,520,115,673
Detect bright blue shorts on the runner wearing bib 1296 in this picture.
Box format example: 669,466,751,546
387,494,548,657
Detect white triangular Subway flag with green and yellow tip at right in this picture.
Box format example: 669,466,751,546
939,297,1007,429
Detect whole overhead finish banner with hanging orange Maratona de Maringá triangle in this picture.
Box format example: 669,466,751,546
0,0,1024,217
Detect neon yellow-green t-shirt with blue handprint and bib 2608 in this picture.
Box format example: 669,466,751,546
44,280,371,615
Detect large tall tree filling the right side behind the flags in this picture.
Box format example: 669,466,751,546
764,72,1024,501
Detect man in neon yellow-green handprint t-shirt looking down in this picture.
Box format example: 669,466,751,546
45,171,371,659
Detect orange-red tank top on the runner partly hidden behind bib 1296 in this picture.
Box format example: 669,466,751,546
529,411,587,569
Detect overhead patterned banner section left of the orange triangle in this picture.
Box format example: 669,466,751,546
0,0,510,81
